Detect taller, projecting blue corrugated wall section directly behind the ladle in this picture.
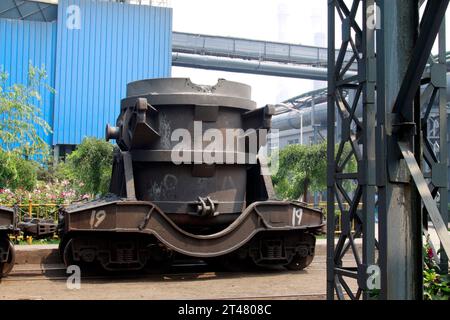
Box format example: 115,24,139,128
53,0,172,144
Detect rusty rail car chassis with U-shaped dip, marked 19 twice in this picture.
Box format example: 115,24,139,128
60,198,324,270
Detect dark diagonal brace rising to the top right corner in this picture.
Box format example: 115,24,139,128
392,0,449,117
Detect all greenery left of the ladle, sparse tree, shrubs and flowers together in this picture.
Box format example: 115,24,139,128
0,64,112,203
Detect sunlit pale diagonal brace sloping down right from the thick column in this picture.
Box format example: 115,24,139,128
398,141,450,255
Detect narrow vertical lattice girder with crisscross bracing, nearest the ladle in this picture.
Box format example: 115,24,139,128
327,0,376,299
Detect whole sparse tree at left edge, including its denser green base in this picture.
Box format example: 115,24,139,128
0,64,53,190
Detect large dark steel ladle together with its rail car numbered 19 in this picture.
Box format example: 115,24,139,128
59,78,324,270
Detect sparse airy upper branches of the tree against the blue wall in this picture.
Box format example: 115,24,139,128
0,63,54,158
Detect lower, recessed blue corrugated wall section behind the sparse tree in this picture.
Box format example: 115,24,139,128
0,19,56,144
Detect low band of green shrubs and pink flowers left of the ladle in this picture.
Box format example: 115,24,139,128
0,138,113,205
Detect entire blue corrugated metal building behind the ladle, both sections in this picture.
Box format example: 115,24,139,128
0,0,172,154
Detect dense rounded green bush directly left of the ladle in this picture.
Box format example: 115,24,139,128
64,138,113,195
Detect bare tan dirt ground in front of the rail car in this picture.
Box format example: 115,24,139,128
0,256,342,300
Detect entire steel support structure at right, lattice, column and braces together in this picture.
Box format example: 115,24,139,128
327,0,450,299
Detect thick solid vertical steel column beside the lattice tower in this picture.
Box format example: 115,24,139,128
377,0,423,299
